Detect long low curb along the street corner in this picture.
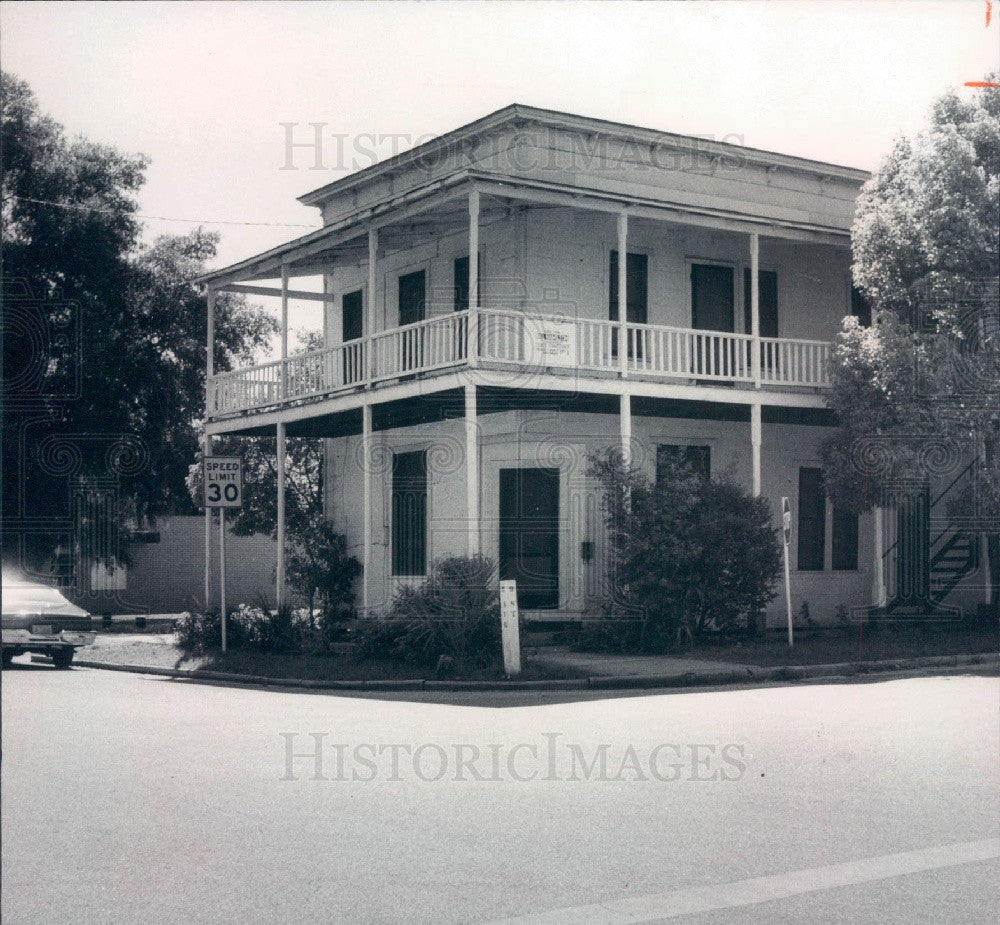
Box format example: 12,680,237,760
56,653,1000,692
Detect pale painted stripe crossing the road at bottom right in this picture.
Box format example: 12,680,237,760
494,838,1000,925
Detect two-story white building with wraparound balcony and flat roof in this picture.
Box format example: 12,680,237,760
195,105,979,622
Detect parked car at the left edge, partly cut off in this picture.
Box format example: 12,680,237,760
0,571,94,668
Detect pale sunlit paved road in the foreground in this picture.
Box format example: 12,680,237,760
2,666,1000,925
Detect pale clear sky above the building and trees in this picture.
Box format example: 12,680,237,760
0,0,1000,338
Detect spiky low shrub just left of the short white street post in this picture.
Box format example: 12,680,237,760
380,556,501,669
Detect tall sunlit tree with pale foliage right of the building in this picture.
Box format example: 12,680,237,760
824,76,1000,599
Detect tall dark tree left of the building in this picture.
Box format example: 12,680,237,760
0,73,275,560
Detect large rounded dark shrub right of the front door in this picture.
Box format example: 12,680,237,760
590,452,781,651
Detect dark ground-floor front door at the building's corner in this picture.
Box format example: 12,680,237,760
500,469,559,610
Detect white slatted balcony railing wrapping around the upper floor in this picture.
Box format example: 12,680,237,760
208,308,831,416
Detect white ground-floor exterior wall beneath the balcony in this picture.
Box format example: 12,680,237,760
320,411,872,624
